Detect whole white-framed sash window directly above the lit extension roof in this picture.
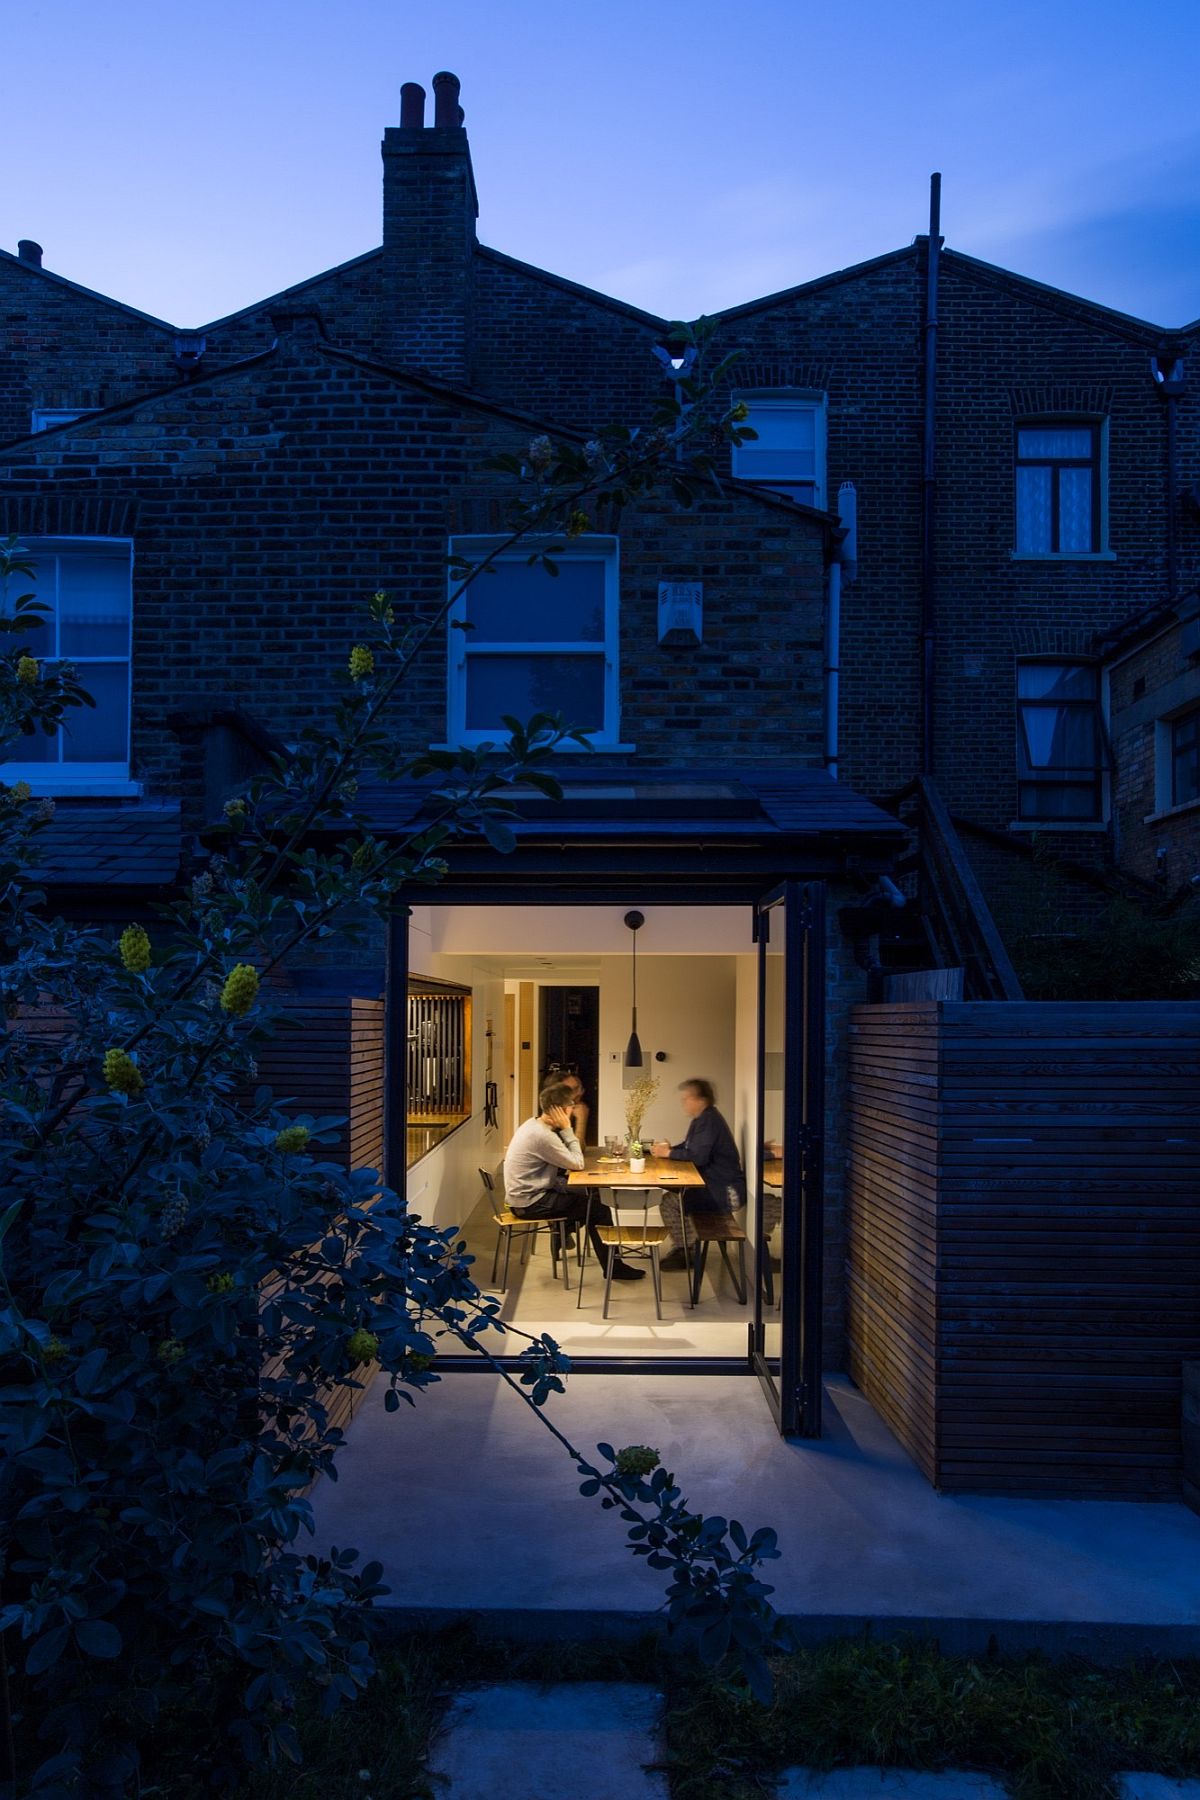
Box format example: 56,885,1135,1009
448,536,621,745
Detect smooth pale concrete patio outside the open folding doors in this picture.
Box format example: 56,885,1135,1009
315,1373,1200,1656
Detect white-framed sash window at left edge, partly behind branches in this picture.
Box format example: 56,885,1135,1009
4,538,133,794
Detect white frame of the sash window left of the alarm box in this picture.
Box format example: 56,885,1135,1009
446,533,630,751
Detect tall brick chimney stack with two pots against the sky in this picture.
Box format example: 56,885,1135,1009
381,70,479,385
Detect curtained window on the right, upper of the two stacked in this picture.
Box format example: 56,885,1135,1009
1016,419,1105,556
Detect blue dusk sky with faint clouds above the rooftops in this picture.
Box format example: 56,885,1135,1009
9,0,1200,326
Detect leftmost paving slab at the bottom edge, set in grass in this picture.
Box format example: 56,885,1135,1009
430,1681,667,1800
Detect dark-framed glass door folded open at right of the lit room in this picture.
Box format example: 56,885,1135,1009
747,882,824,1438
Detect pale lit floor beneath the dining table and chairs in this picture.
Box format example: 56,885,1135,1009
462,1195,752,1359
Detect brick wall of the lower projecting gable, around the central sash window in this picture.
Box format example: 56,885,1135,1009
0,322,824,824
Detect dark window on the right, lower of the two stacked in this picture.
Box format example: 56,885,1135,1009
1016,662,1105,823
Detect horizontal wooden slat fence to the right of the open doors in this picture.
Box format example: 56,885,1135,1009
847,1001,1200,1494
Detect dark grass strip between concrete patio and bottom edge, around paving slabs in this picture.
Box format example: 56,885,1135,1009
25,1625,1200,1800
